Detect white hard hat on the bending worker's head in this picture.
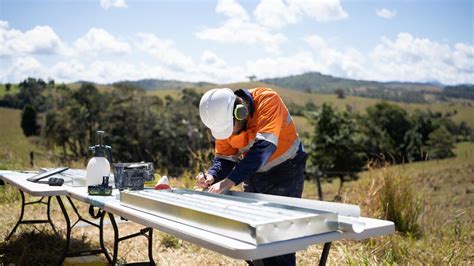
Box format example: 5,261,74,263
199,88,236,139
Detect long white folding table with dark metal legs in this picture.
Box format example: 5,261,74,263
0,171,394,265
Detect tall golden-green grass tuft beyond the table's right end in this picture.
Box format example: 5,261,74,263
379,162,424,237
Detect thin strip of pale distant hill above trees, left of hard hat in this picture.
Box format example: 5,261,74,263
112,79,212,90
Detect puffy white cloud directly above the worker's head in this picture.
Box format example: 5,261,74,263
195,19,287,53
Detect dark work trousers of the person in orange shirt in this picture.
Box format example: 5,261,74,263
244,149,307,265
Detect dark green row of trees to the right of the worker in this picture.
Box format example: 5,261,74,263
305,101,472,187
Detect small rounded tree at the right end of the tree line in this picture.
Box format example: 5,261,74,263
428,126,454,159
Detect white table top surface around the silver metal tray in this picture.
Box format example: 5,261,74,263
0,171,395,260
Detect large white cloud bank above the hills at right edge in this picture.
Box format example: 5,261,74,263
305,33,474,84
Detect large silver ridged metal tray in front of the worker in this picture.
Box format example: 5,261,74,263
120,189,338,245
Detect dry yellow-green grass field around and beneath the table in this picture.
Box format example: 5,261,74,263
0,143,474,265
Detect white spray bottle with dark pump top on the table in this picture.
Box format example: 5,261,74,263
86,131,112,186
